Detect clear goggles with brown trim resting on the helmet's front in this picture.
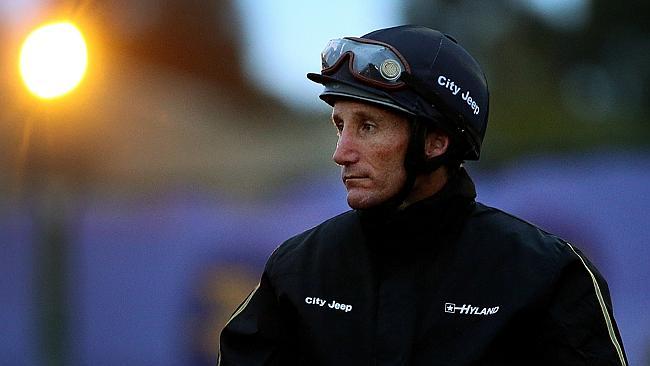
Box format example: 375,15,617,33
321,37,411,89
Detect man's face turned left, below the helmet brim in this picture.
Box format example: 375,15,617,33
332,100,410,209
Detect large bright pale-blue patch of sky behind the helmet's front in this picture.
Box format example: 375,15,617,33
235,0,403,110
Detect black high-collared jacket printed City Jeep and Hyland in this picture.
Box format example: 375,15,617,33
219,170,627,366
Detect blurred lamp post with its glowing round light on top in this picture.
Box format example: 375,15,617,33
19,21,88,365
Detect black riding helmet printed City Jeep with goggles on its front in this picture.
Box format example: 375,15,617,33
307,25,489,160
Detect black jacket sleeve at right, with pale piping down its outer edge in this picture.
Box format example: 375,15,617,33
537,243,627,366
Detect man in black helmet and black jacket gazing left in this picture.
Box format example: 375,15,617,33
219,26,627,365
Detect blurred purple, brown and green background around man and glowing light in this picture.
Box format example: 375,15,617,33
0,0,650,365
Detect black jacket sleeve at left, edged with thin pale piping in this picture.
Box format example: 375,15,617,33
217,271,287,366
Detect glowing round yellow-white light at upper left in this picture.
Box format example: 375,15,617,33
20,22,88,99
